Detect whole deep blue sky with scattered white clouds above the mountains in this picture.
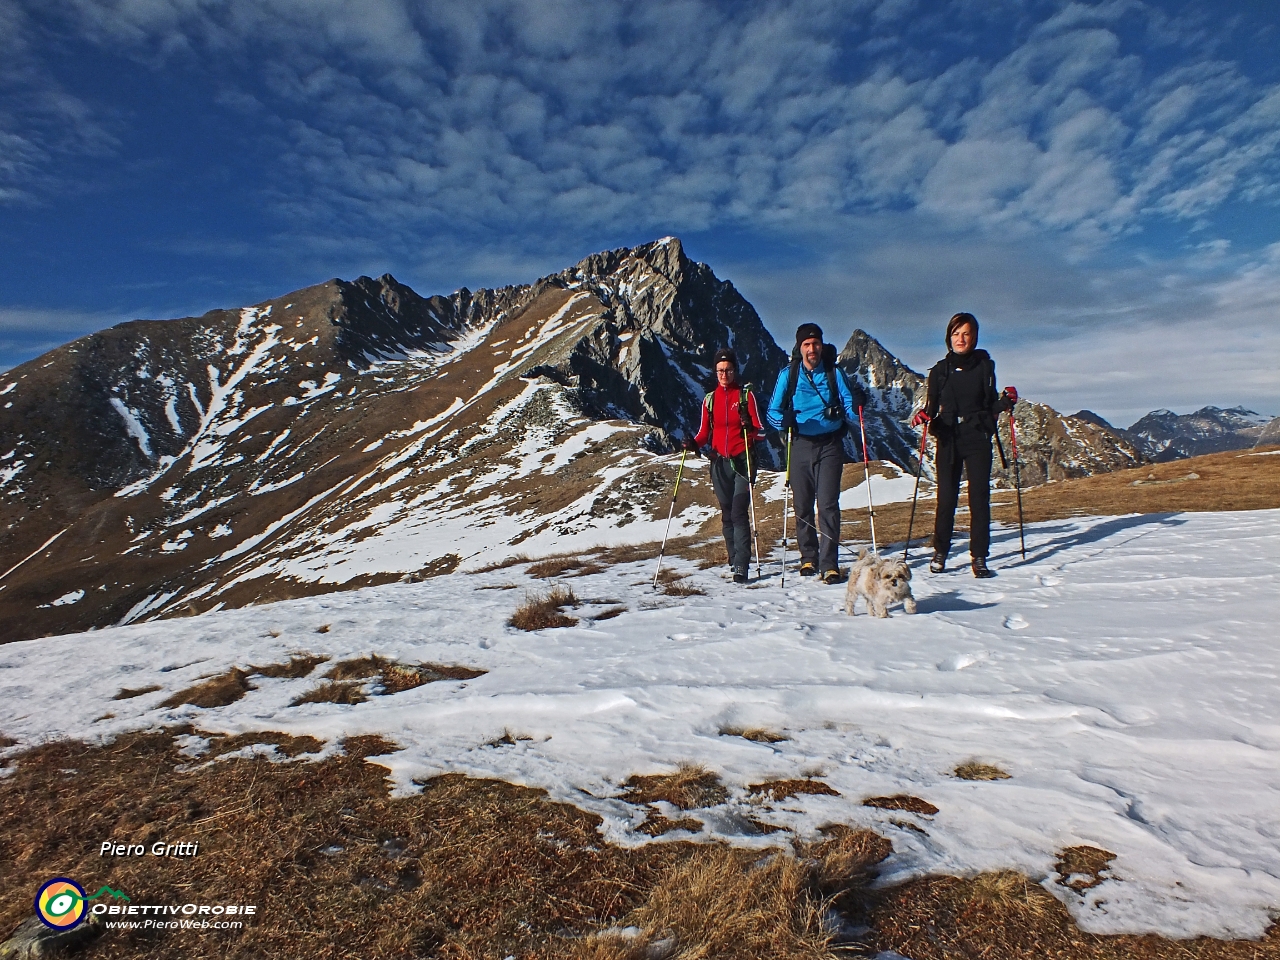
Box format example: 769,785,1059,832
0,0,1280,425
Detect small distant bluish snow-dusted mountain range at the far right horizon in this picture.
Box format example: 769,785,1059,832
1073,407,1280,463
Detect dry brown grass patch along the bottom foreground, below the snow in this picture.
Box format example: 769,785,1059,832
0,727,1280,960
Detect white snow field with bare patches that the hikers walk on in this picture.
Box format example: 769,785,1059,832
0,511,1280,937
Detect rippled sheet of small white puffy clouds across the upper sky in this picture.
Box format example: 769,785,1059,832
13,0,1280,242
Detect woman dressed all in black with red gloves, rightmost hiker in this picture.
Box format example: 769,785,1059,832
911,314,1018,577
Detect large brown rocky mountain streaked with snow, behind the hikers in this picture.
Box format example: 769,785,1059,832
0,238,1269,640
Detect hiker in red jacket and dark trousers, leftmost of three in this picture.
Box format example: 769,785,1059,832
685,348,760,584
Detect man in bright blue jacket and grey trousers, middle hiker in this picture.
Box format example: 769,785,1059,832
765,324,867,584
